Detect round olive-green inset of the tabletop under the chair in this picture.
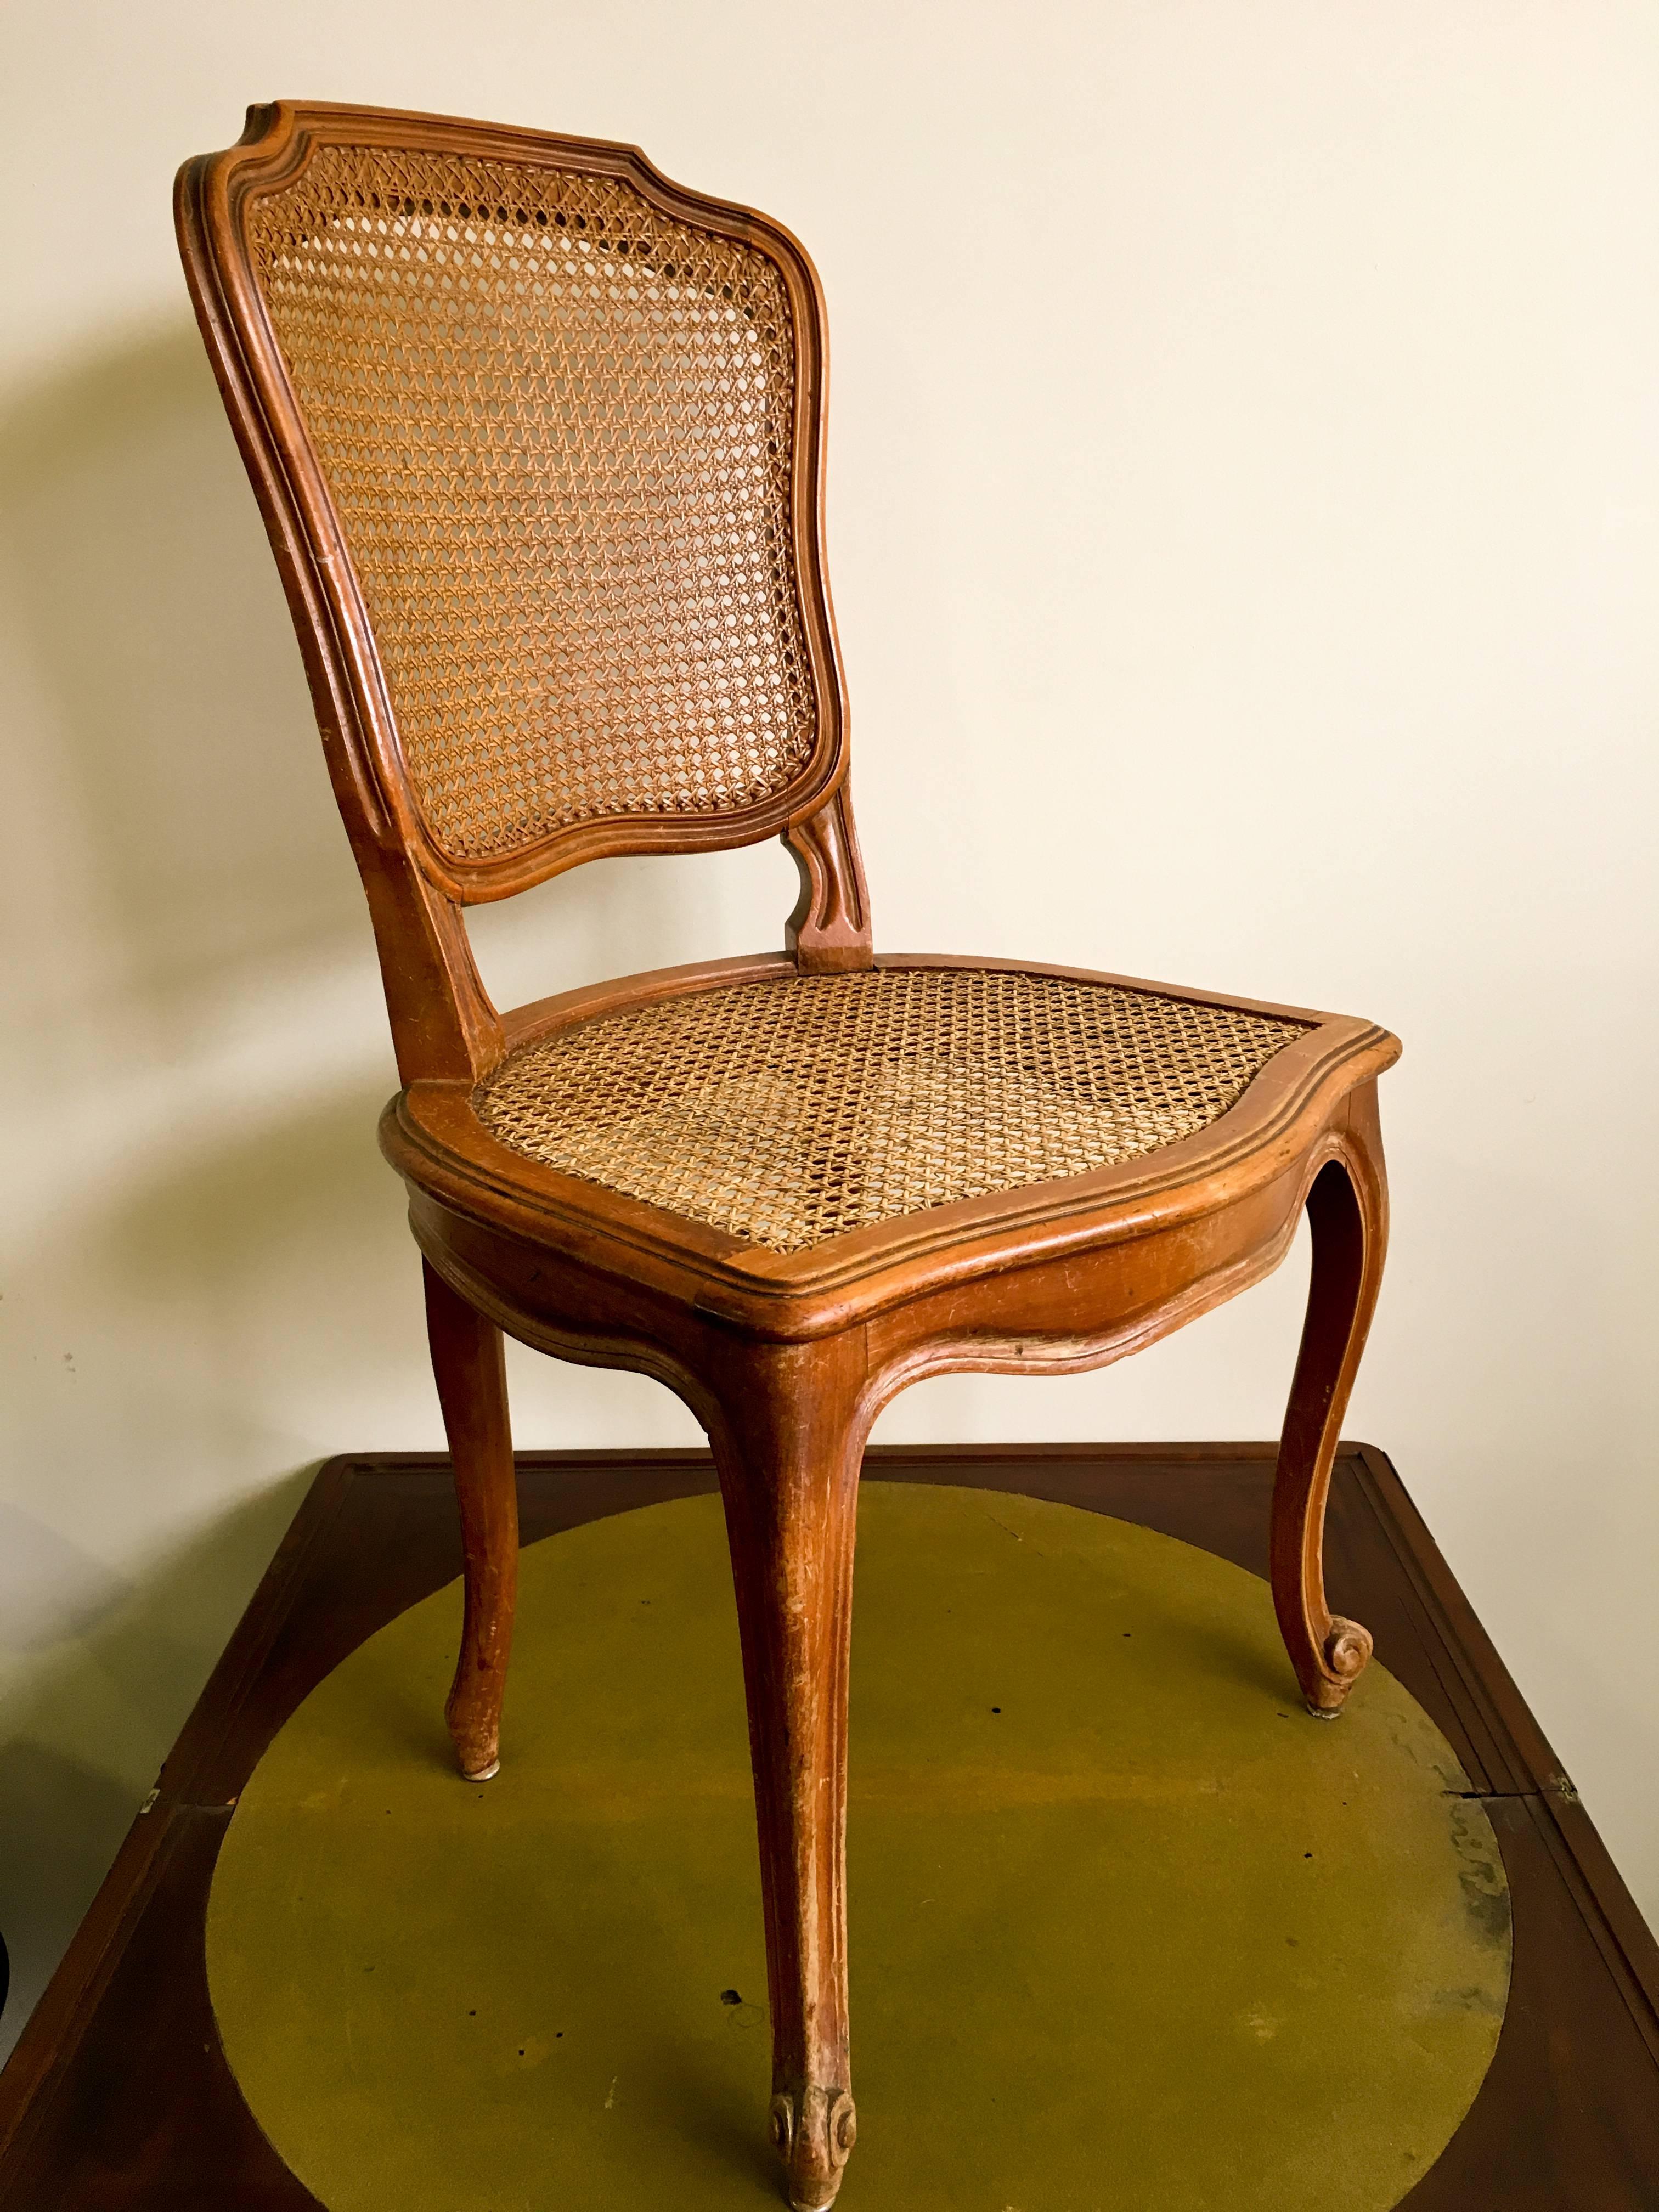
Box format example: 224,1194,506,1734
208,1482,1509,2212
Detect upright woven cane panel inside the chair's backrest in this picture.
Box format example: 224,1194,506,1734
248,131,816,860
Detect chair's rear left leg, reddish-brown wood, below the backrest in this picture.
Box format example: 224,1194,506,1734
420,1261,517,1783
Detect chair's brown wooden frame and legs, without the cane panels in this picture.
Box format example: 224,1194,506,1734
175,101,1398,2212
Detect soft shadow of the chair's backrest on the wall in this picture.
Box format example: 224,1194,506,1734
0,323,363,1013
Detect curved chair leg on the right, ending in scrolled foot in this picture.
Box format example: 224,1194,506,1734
1272,1088,1387,1721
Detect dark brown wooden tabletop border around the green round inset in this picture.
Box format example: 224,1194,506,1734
0,1444,1659,2212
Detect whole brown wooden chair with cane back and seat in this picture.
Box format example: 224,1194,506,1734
177,101,1398,2212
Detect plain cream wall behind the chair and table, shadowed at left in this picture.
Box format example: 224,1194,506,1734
0,0,1659,2042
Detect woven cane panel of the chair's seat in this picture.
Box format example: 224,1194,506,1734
473,969,1305,1252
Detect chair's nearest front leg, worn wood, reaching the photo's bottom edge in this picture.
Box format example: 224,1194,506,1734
714,1342,865,2212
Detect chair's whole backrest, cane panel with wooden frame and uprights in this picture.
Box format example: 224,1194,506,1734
177,101,870,1082
